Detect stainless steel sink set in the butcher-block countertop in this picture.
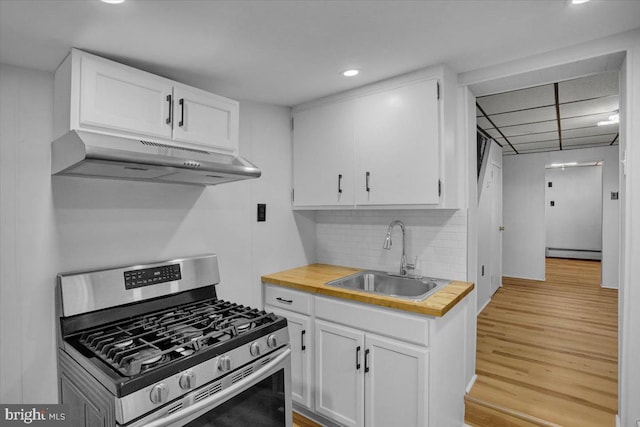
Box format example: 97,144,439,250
326,270,450,301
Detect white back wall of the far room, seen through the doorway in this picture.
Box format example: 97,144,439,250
544,165,611,259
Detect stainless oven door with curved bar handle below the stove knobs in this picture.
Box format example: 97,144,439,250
136,346,293,427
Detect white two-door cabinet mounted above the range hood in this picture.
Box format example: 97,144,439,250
55,49,239,154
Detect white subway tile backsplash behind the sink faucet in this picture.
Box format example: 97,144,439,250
316,210,467,280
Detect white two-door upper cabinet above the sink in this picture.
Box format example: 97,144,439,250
293,67,462,209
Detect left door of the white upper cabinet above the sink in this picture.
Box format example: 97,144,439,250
293,101,354,207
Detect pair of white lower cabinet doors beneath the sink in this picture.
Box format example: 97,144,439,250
315,320,428,427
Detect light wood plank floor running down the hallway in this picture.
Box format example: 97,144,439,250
465,259,618,427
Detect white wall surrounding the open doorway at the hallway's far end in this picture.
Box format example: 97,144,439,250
503,146,620,287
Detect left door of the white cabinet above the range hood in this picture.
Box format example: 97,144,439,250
79,56,173,138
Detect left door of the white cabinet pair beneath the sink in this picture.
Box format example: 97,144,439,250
315,320,364,426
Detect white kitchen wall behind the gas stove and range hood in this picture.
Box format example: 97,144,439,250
0,65,315,403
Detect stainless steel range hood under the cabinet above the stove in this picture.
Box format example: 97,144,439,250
51,130,261,185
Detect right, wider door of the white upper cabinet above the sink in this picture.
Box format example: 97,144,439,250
355,80,440,205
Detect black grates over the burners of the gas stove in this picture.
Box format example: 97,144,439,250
78,298,277,377
